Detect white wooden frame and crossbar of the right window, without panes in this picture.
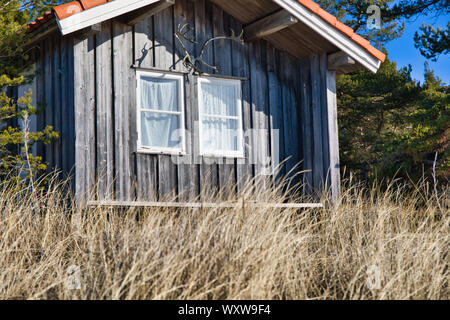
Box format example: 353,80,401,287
197,77,244,158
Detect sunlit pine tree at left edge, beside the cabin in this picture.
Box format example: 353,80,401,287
0,0,64,181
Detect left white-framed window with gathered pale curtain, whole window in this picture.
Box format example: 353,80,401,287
136,71,185,154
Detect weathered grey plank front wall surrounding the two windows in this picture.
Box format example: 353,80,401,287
71,0,338,201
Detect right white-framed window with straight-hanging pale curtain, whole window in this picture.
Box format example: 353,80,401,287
198,78,244,157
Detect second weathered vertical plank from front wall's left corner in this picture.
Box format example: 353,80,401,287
95,22,114,200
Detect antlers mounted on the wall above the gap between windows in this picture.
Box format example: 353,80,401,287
175,24,244,75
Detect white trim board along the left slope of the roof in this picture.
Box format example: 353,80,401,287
56,0,159,36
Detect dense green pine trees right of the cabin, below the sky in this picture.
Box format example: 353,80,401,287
337,60,450,181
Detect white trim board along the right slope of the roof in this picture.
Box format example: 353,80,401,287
273,0,381,73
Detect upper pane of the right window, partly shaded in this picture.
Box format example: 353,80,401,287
201,80,238,117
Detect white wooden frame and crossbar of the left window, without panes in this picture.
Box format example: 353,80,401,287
136,70,186,155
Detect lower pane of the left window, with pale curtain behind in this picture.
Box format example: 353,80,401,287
141,111,182,148
